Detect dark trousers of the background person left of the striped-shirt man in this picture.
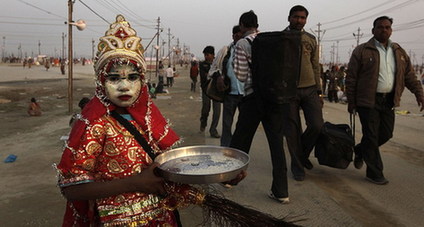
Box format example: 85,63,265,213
200,91,221,134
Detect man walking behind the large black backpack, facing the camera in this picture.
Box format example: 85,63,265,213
285,5,324,181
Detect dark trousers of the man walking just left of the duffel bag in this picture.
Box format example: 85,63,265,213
285,86,324,176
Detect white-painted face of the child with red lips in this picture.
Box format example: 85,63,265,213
105,65,142,107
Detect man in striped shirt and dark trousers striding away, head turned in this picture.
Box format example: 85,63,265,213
230,11,289,204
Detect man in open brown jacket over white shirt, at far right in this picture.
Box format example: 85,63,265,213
346,16,424,185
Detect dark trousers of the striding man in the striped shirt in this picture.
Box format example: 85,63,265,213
230,94,289,197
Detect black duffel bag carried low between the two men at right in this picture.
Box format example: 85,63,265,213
315,122,355,169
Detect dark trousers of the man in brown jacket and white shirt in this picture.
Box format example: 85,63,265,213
355,94,395,179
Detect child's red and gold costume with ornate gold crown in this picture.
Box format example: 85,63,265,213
57,15,203,226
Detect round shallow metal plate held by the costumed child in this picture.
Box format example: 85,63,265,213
155,145,249,184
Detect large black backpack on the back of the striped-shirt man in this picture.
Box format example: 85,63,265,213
247,31,302,104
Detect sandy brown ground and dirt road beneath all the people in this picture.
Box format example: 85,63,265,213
0,65,424,227
